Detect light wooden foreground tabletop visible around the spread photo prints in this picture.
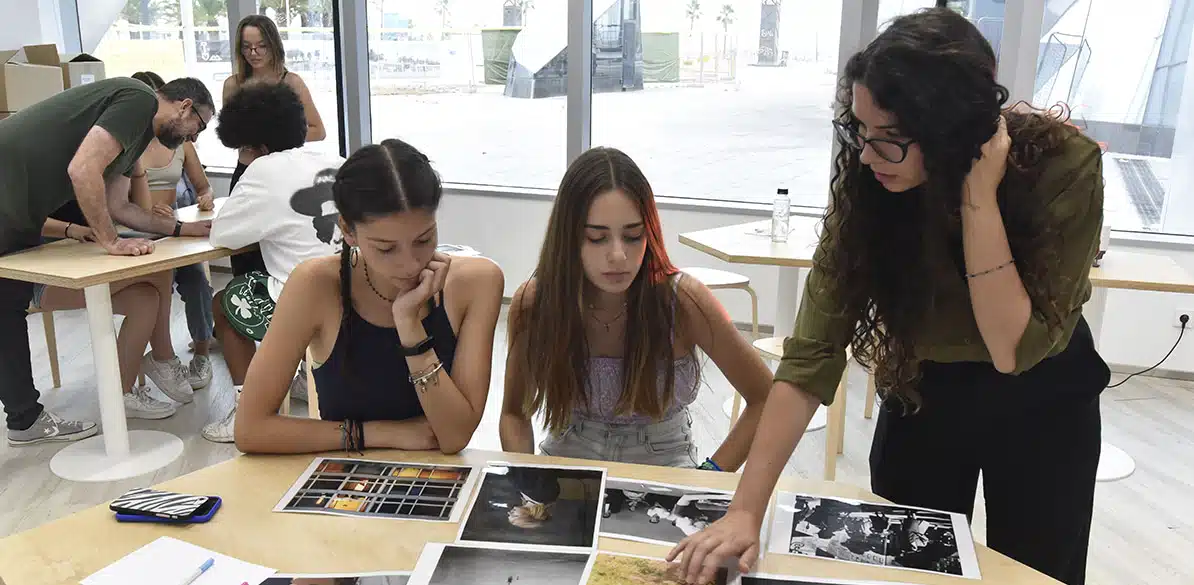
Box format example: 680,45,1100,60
0,450,1057,585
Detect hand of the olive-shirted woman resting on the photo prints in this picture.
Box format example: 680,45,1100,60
667,510,759,583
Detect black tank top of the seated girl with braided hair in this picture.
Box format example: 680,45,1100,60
313,293,456,421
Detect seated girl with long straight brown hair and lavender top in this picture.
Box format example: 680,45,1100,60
499,148,771,470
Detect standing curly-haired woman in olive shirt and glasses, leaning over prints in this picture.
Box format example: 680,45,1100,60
670,8,1110,585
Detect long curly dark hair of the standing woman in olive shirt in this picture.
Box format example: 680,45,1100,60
816,8,1076,412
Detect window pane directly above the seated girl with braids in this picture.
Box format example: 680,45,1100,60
368,0,567,189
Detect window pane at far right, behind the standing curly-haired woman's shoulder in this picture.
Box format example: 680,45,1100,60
1034,0,1194,233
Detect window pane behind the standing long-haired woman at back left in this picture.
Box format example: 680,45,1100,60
96,0,339,168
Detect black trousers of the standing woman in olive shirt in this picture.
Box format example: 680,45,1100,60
870,319,1110,585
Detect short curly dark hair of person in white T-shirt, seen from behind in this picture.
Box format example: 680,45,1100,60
216,81,307,153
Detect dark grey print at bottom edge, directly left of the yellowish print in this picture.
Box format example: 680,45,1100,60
410,543,593,585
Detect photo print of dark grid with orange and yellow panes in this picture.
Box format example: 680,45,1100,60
273,457,479,522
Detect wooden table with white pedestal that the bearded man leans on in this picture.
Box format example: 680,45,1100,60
0,201,244,481
